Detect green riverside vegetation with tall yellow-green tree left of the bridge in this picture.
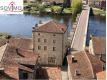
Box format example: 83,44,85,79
24,0,82,14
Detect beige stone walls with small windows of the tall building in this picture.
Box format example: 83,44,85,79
33,32,67,65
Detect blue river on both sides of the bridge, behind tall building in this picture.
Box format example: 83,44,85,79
0,15,106,37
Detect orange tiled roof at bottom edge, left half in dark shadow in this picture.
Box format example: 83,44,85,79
36,67,61,80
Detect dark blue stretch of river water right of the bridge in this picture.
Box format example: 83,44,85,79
86,16,106,46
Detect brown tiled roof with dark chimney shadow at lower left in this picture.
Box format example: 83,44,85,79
0,43,38,80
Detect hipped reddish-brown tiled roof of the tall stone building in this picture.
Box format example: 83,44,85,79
33,21,67,33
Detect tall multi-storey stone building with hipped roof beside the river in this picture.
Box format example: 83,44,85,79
32,21,67,66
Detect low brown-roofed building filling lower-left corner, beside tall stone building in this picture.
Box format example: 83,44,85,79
0,38,38,80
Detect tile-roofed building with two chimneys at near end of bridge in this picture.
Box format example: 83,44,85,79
67,51,103,80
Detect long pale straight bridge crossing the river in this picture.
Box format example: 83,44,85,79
71,5,90,53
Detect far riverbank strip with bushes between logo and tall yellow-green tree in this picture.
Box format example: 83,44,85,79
24,3,72,14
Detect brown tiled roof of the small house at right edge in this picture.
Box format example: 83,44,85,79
92,37,106,54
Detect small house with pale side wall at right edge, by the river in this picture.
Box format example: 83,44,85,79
89,37,106,63
